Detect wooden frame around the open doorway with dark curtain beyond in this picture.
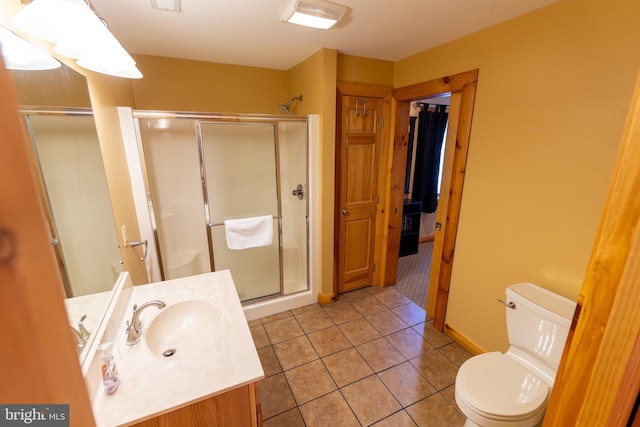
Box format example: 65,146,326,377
384,69,478,331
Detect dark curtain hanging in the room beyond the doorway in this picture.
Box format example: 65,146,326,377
412,105,449,213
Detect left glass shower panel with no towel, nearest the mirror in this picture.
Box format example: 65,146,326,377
139,118,211,280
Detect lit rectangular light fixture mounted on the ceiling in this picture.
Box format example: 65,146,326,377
282,0,349,30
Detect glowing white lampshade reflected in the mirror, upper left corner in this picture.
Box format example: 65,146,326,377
0,26,60,71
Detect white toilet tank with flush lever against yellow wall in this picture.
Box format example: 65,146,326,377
506,283,576,380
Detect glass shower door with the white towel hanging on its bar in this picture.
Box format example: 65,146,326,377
200,123,282,301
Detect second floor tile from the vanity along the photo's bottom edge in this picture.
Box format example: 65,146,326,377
300,391,360,427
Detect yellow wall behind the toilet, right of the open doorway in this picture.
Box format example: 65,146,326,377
394,0,640,350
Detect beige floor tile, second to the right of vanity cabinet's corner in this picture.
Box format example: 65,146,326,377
284,360,337,405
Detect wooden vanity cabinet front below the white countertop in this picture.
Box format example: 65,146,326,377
134,382,262,427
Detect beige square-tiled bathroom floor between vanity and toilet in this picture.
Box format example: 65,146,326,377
249,287,471,427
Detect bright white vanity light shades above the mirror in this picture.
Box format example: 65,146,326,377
11,0,142,79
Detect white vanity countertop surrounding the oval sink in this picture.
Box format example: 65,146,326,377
89,270,264,427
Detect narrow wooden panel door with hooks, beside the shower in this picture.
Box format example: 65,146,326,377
337,96,382,293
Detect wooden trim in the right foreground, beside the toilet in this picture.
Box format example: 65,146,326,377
544,71,640,426
